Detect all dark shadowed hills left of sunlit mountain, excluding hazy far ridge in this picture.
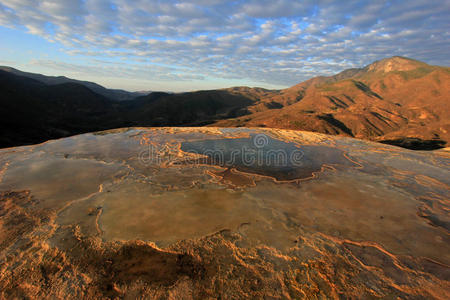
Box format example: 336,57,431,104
0,70,254,147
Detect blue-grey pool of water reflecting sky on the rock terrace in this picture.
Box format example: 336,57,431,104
181,134,356,180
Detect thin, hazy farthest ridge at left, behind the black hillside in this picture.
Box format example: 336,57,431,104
0,66,146,101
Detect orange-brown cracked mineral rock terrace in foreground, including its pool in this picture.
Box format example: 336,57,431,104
0,127,450,299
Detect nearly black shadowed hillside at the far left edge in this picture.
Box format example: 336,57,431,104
0,71,118,147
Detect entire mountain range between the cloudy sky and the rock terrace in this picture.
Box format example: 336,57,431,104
0,57,450,149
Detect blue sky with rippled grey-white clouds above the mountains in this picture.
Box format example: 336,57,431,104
0,0,450,92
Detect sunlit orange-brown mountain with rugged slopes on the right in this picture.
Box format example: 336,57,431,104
214,57,450,149
